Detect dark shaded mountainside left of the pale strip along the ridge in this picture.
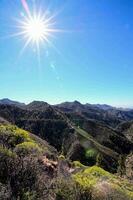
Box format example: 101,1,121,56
0,102,74,150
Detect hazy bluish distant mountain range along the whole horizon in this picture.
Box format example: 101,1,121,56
0,99,133,128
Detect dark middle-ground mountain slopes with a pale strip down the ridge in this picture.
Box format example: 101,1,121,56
0,101,132,172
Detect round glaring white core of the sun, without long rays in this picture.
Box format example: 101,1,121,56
18,12,54,47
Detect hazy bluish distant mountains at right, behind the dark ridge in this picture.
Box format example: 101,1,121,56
55,101,133,128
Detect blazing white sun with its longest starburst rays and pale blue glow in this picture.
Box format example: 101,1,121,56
6,0,64,63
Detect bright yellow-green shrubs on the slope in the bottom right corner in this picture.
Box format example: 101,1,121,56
73,166,133,200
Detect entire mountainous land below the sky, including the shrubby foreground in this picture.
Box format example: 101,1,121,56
0,101,133,200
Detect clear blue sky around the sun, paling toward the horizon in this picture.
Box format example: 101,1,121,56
0,0,133,107
